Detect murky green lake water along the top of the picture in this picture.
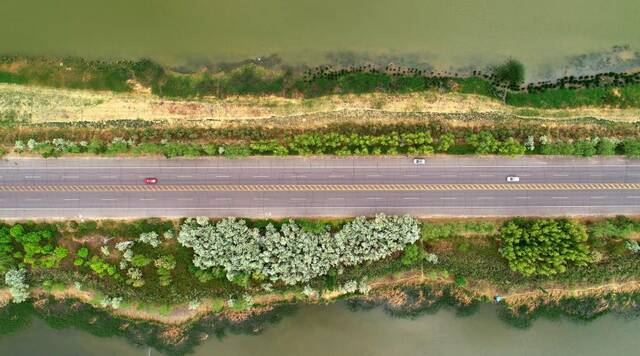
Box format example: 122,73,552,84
0,0,640,76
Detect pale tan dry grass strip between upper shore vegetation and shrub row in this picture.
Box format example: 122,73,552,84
0,83,640,127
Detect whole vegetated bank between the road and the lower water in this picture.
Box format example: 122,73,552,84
0,215,640,353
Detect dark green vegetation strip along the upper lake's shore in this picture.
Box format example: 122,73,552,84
0,56,640,108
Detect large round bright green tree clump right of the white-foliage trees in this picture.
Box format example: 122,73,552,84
498,218,592,276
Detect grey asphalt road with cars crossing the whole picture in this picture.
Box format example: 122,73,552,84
0,157,640,218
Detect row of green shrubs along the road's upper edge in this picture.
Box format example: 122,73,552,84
13,131,640,158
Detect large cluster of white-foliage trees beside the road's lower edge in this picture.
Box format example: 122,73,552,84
178,214,420,285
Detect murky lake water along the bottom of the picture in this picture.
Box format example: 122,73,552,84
0,303,640,356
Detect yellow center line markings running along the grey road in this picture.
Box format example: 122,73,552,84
0,183,640,192
